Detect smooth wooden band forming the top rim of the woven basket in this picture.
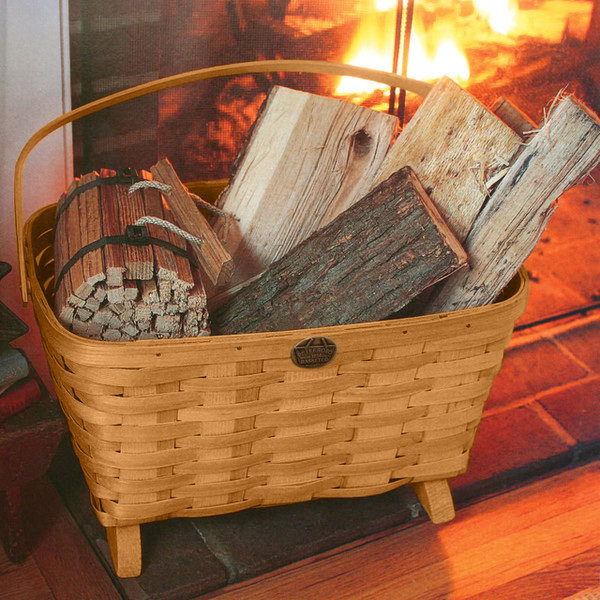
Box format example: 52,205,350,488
24,204,529,366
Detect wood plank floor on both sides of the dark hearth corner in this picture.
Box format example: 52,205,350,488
0,462,600,600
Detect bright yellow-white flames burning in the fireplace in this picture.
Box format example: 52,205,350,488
335,0,592,101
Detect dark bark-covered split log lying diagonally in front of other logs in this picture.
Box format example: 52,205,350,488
212,168,466,333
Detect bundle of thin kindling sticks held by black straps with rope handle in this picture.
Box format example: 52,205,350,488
54,160,231,340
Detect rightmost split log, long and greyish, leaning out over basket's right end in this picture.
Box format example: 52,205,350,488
424,97,600,313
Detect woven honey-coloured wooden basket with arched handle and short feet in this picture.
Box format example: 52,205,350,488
14,60,529,577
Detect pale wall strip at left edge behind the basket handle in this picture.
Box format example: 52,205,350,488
0,0,72,392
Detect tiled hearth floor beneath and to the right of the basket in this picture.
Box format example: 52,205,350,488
51,174,600,600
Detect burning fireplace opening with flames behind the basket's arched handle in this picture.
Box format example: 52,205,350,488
70,0,600,181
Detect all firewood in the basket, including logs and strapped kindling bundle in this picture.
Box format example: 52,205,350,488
56,78,600,340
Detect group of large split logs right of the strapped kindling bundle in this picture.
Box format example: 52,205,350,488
211,78,600,333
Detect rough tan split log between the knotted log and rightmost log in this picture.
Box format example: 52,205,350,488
376,77,521,241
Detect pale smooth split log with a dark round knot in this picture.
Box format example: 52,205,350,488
213,86,397,285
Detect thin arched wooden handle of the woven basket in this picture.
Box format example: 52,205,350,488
14,60,431,305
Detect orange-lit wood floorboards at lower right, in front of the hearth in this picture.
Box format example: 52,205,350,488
206,463,600,600
